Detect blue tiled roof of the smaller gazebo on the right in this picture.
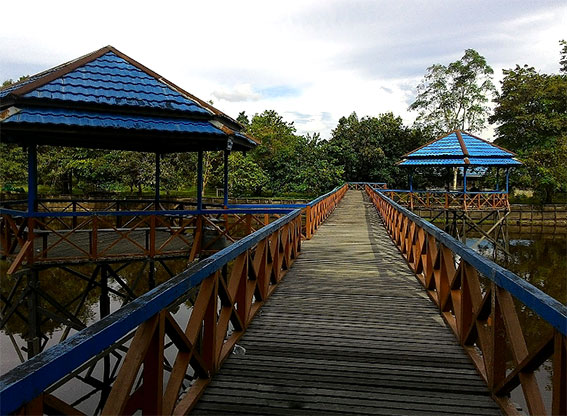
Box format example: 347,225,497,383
398,130,522,167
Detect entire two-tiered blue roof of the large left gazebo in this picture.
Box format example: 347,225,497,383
0,46,258,153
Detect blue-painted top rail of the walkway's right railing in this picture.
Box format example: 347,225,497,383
373,190,567,335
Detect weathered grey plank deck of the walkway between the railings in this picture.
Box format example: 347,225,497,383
192,191,500,415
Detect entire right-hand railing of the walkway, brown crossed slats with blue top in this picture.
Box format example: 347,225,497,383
366,186,567,415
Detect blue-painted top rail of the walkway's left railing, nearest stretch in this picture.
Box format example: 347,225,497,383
0,210,300,415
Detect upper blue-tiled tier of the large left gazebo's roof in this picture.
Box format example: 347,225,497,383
23,52,210,115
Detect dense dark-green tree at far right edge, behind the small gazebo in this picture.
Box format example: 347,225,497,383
490,41,567,203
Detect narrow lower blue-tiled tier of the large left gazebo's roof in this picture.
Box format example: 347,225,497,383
3,107,224,136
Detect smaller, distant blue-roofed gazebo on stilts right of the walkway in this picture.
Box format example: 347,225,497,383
390,130,522,253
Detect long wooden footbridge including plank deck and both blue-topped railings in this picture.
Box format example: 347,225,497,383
0,184,567,415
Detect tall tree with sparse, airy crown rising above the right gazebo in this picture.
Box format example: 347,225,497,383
409,49,495,134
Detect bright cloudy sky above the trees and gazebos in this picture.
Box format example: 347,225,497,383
0,0,567,138
